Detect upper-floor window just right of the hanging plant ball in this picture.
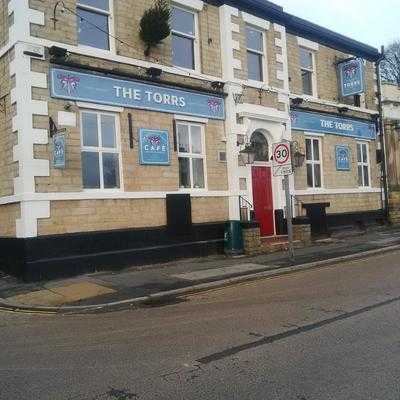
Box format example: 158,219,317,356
171,6,197,70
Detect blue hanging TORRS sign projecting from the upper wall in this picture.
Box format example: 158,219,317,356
338,58,365,97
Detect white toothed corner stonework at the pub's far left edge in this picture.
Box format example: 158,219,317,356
8,0,50,238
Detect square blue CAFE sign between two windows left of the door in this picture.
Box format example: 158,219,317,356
139,129,170,165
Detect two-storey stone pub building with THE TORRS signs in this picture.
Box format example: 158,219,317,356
0,0,382,279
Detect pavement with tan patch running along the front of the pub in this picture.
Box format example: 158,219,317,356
0,223,400,313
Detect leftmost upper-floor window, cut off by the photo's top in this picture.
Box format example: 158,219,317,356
76,0,110,50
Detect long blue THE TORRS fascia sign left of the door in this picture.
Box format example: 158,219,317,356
50,68,225,120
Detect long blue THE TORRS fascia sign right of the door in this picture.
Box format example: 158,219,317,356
290,111,376,140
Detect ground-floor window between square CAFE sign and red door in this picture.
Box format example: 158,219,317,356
176,122,206,189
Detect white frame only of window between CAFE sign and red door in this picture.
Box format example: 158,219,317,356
175,120,208,192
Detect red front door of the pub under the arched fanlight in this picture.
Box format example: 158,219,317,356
251,167,275,236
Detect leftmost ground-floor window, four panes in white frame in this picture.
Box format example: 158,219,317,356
81,111,120,189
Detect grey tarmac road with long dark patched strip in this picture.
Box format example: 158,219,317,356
0,252,400,400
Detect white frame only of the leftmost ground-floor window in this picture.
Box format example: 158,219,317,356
79,109,124,192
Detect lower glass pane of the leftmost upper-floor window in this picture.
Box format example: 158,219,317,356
76,8,110,50
